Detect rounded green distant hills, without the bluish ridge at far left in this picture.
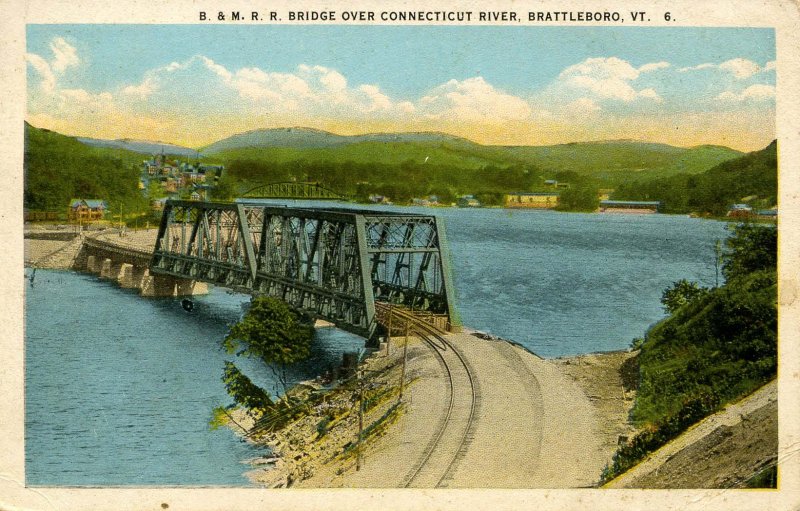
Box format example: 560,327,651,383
209,135,742,193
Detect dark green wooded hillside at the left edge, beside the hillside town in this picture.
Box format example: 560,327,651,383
24,123,146,212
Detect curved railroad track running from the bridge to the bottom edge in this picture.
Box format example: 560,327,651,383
376,304,480,488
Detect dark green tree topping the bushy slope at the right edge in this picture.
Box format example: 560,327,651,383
722,223,778,280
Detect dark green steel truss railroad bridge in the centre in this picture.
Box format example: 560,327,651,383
150,200,455,339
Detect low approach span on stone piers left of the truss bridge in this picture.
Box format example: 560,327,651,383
74,239,208,297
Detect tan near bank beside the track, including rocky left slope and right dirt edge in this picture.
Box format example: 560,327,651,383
220,334,633,488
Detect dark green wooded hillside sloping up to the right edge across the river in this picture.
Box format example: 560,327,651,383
613,141,778,215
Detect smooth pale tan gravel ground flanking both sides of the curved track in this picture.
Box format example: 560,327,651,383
282,334,622,488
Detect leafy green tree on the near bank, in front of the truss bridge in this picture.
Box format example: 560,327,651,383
223,296,314,394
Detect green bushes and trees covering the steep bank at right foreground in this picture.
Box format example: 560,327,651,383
604,224,778,481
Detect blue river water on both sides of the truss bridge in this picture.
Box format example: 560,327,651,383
25,208,726,486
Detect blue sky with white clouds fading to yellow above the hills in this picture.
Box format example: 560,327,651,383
26,25,776,151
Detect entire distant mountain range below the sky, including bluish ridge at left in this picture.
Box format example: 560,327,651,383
70,127,742,176
